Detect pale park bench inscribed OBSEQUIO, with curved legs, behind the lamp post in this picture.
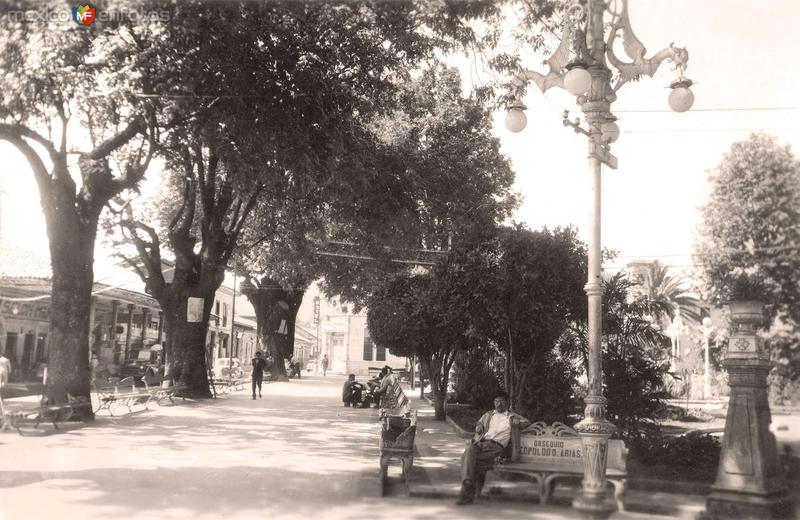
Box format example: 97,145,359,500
489,422,628,511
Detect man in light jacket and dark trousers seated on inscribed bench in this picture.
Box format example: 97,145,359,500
456,394,530,506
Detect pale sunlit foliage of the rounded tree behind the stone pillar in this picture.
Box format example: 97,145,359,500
695,134,800,323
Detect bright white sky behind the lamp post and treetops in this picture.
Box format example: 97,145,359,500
0,0,800,280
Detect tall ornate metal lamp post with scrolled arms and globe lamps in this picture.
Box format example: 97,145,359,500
506,0,694,518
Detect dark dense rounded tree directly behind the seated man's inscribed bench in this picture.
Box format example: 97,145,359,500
440,227,586,414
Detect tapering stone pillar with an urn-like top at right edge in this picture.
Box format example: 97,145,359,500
706,301,793,519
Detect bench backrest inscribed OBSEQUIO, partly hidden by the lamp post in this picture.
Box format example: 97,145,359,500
512,422,628,472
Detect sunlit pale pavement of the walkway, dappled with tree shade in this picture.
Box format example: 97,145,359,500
0,374,792,520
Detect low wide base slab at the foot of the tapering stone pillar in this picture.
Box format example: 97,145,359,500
706,490,794,520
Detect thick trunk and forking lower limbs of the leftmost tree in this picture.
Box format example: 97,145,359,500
0,117,152,414
